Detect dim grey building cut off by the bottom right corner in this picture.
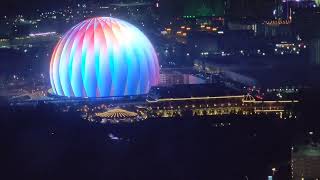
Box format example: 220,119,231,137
291,144,320,180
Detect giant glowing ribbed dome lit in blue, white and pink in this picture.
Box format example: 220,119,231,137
50,17,159,97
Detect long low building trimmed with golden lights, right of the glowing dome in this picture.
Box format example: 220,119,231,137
140,95,298,119
